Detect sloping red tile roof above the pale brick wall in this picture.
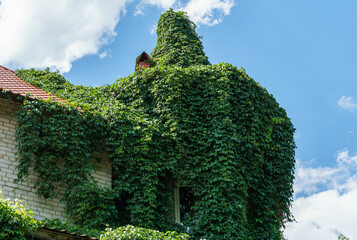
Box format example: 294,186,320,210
0,65,67,103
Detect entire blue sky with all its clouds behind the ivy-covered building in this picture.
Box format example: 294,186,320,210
0,0,357,240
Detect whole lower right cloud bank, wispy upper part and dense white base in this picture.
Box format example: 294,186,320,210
285,149,357,240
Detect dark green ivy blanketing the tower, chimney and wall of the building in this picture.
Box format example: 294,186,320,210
13,10,295,239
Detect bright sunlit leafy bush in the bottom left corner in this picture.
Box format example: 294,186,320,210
0,190,38,240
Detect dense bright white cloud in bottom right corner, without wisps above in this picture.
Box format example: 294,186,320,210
285,186,357,240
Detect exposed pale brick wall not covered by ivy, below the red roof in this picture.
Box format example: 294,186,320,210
0,98,112,220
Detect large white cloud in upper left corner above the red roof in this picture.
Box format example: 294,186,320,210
0,0,130,72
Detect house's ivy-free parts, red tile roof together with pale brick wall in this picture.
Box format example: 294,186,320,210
0,65,112,239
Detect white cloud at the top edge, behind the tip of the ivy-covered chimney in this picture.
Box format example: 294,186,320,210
134,0,235,26
